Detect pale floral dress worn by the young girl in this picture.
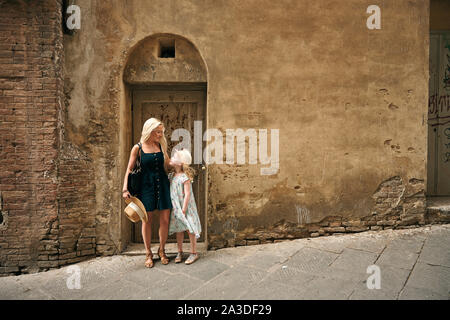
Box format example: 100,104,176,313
169,172,202,238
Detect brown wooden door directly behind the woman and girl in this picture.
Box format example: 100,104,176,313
132,88,206,243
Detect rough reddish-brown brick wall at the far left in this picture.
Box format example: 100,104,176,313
0,0,95,275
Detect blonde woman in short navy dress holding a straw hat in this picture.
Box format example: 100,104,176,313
122,118,172,268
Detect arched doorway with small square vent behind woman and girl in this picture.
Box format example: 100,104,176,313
123,34,207,249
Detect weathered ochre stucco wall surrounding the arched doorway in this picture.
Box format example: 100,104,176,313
64,0,429,254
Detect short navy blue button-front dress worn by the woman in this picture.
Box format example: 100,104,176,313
139,144,172,212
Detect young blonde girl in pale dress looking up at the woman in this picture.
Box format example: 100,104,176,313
169,149,202,264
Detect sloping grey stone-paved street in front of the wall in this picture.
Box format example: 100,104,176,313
0,224,450,300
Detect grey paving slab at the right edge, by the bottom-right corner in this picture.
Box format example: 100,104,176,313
406,262,450,296
